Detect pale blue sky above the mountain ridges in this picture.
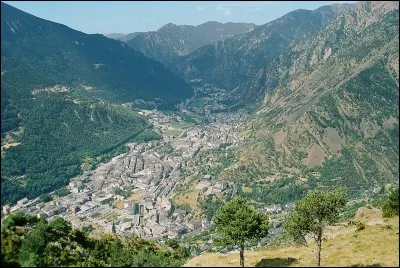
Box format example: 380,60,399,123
4,1,355,34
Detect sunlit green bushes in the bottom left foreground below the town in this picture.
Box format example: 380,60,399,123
1,213,190,267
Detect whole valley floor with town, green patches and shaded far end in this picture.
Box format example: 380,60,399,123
3,81,390,254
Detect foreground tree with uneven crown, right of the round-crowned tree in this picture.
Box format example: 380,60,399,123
283,190,347,267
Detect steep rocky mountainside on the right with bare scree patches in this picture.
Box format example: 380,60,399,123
219,1,399,201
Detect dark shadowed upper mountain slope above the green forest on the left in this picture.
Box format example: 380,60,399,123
1,3,192,105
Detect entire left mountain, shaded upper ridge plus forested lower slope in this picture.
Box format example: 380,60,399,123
1,3,193,203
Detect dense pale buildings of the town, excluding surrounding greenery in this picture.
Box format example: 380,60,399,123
3,108,247,242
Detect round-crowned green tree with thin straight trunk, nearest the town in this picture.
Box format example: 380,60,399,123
214,197,269,267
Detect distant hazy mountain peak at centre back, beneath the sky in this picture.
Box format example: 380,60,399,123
125,21,256,66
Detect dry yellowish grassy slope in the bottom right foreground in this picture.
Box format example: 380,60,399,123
185,207,399,267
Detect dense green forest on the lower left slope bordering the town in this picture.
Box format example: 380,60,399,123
1,92,160,203
